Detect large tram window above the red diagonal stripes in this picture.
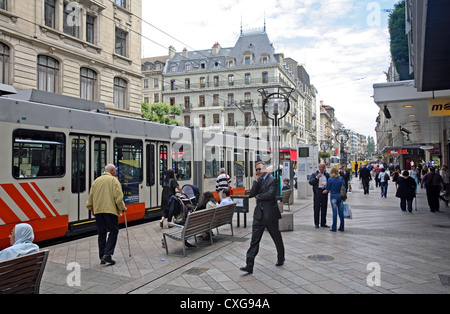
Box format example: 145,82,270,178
12,129,66,179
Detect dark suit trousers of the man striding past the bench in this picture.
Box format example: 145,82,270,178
247,209,284,269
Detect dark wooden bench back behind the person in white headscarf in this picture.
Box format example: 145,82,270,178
0,250,48,294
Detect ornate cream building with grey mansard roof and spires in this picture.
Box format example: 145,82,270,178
162,28,315,149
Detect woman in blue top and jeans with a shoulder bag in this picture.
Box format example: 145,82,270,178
322,167,345,232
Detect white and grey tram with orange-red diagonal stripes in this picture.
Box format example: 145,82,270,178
0,90,270,249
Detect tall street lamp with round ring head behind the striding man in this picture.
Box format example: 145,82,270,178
258,87,295,196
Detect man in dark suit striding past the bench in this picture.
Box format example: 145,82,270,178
241,162,284,274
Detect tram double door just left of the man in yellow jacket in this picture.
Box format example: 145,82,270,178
68,135,89,222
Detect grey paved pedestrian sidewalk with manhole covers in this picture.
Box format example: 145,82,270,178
41,183,450,294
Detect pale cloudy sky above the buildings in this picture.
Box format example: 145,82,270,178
142,0,399,136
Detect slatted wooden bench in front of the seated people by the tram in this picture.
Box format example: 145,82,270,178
163,204,236,256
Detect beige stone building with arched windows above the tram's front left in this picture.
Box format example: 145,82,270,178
0,0,142,117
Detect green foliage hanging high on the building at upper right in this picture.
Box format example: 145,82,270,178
389,0,409,70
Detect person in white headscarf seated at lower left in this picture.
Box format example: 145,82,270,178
0,224,39,262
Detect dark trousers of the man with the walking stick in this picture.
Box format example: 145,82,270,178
95,214,119,258
